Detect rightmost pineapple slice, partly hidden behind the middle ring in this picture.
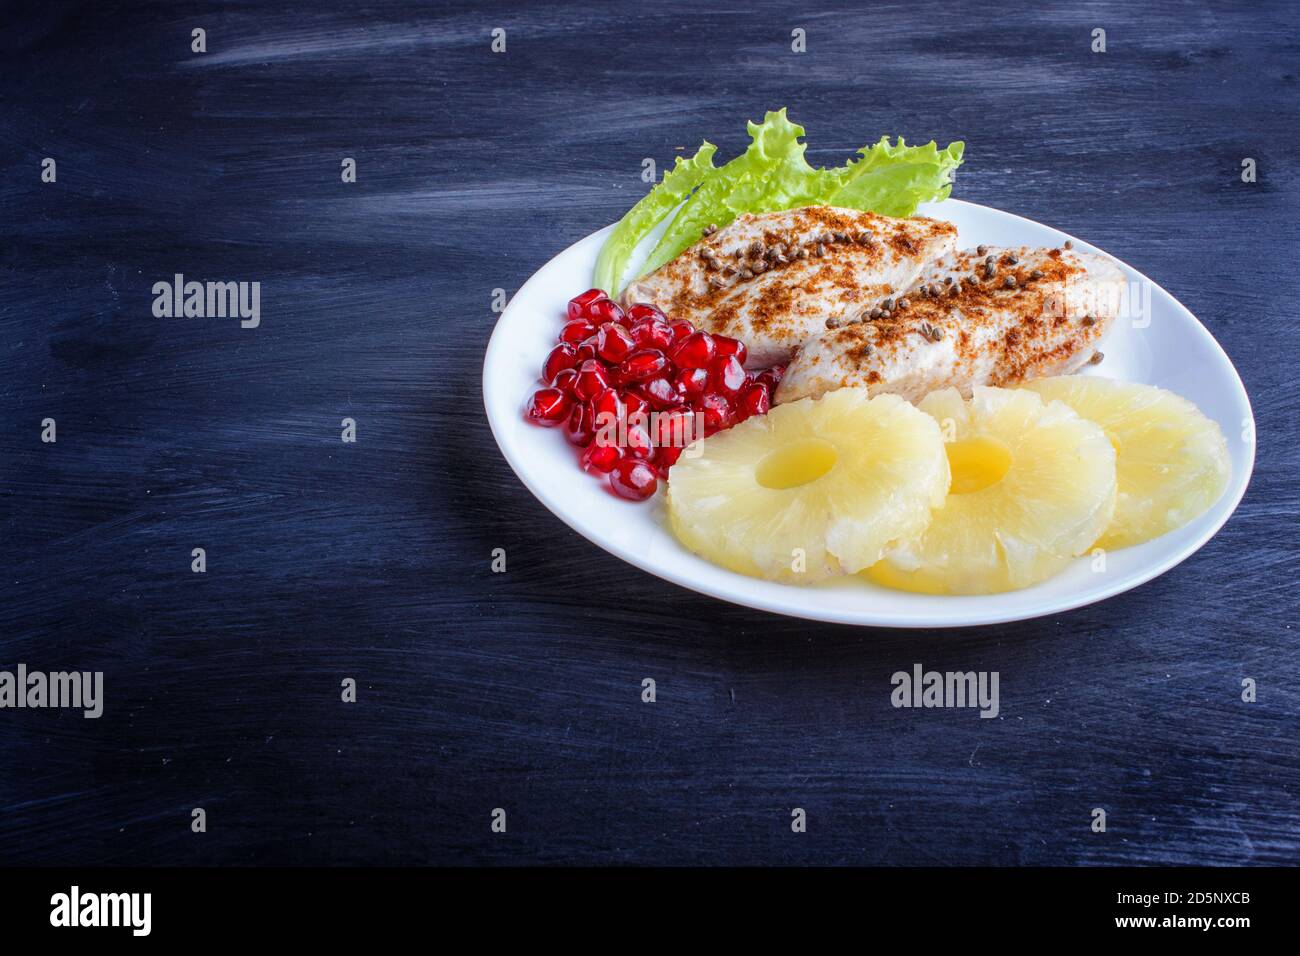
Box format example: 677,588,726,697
1026,375,1232,549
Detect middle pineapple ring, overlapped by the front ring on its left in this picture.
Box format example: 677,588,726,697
866,388,1115,594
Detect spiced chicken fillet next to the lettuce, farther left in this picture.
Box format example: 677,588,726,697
623,206,957,368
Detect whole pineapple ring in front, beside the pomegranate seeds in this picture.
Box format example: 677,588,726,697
667,389,948,584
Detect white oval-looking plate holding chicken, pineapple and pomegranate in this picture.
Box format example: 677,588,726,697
484,199,1255,627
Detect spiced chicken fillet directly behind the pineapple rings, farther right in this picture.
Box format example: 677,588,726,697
776,247,1126,402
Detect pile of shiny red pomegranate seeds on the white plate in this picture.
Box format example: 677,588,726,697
525,289,785,501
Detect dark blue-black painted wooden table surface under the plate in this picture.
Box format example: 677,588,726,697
0,0,1300,864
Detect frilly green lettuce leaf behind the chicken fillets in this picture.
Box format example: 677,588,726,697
595,109,965,295
